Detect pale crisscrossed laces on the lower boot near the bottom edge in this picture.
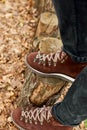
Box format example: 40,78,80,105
20,106,52,125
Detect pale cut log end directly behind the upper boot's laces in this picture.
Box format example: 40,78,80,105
33,36,62,53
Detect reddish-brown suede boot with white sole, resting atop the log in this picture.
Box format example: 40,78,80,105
26,51,87,82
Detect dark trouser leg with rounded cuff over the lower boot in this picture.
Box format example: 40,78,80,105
52,67,87,126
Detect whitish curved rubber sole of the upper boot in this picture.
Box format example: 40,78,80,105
25,56,75,83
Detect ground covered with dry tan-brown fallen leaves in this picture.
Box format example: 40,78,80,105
0,0,85,130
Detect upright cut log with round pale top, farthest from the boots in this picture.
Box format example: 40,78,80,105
36,12,58,37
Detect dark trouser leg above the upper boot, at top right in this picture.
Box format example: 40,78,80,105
53,0,87,62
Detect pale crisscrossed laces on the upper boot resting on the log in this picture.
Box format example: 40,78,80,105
34,50,67,66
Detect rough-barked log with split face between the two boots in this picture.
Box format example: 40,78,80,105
17,69,67,107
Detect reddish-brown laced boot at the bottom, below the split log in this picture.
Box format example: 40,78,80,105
12,106,73,130
